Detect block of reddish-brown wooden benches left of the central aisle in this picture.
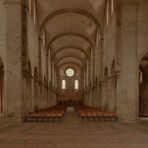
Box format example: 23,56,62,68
24,106,66,122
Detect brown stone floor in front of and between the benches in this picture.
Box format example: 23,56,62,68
0,107,148,148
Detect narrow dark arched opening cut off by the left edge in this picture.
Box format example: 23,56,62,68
0,59,4,114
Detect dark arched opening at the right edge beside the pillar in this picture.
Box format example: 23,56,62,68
139,53,148,117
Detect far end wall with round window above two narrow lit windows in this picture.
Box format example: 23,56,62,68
57,63,84,106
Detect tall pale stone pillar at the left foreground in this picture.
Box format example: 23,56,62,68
5,0,22,120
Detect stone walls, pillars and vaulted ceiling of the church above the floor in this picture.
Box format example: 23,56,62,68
0,0,148,122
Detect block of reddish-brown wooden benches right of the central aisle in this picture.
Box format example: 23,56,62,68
75,106,118,121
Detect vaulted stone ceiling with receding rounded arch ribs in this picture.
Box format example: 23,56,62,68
37,0,106,71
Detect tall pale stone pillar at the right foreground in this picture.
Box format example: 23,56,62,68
118,0,139,122
